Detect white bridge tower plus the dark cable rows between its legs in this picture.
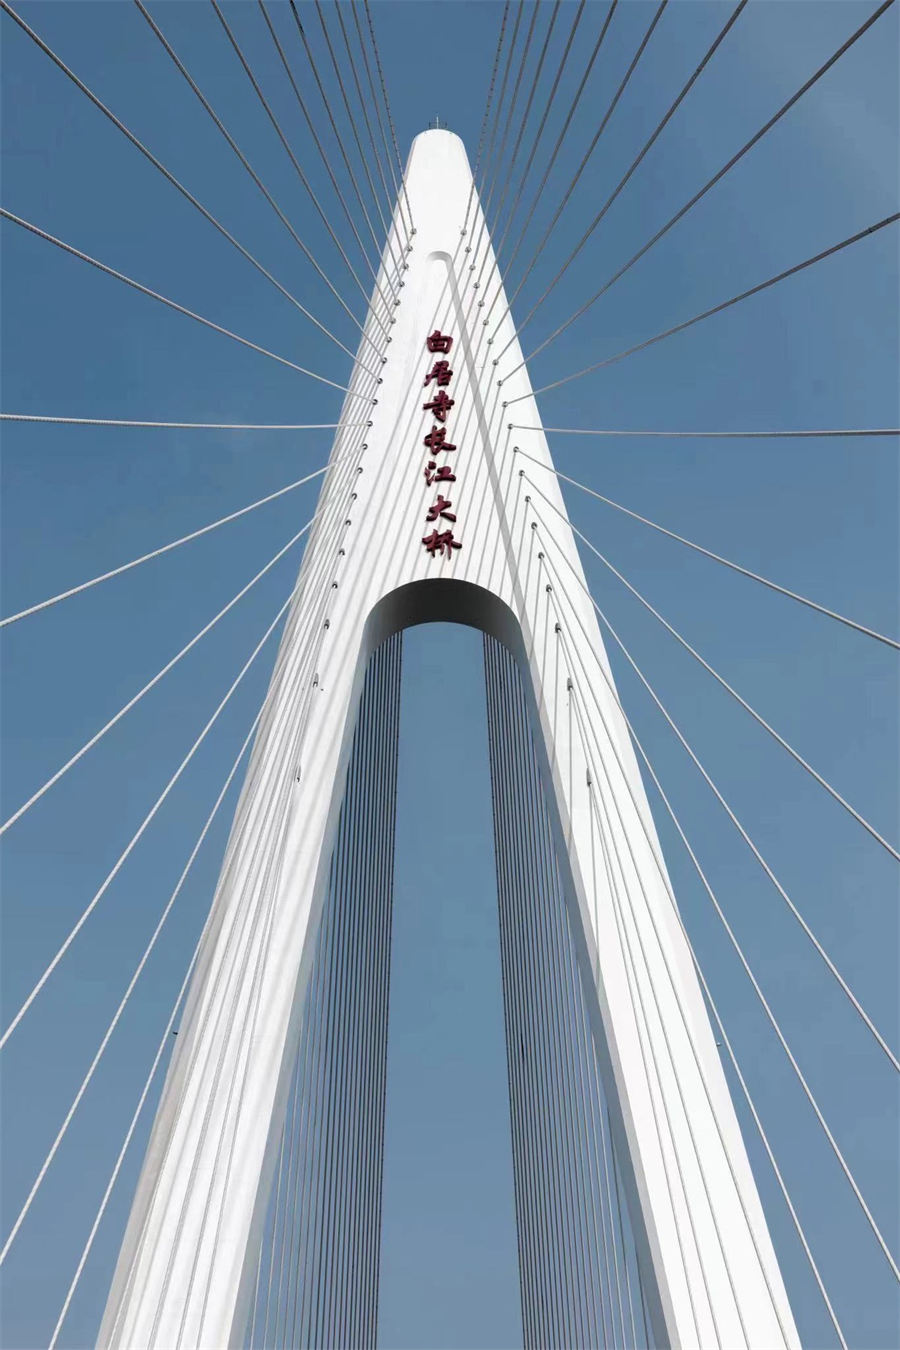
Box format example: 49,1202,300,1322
100,130,797,1347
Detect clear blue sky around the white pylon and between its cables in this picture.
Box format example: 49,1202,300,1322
0,0,900,1350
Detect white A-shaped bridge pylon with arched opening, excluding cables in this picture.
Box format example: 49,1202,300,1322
100,131,799,1350
